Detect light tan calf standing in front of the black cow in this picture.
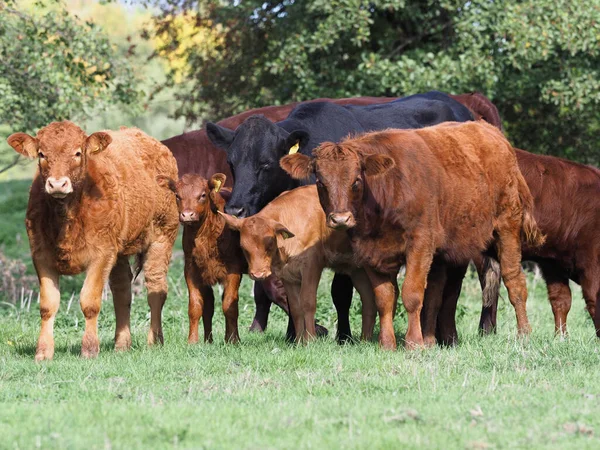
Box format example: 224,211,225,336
223,185,376,342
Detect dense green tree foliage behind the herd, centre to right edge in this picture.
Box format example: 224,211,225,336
149,0,600,164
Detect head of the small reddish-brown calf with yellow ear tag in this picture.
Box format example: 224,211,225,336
156,173,226,225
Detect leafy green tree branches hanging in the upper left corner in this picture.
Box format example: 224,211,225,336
0,0,140,172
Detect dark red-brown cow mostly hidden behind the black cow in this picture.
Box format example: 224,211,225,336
162,97,396,337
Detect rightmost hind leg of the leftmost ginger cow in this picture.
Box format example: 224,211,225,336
144,236,173,345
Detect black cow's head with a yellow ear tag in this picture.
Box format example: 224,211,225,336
206,116,308,218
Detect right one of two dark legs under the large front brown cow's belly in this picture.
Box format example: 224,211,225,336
436,265,469,345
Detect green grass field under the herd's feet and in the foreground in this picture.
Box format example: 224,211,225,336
0,178,600,449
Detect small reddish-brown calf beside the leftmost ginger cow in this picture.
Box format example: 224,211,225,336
158,173,247,343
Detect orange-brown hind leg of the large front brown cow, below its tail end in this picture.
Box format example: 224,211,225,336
496,227,531,335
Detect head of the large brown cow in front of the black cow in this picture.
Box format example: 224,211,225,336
281,142,394,230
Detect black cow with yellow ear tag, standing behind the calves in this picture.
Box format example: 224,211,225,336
206,91,473,340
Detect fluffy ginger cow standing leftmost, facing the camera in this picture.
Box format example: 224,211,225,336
8,122,179,361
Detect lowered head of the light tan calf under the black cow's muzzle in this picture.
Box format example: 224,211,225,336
222,214,294,280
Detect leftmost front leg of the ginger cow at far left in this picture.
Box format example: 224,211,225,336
34,258,60,361
